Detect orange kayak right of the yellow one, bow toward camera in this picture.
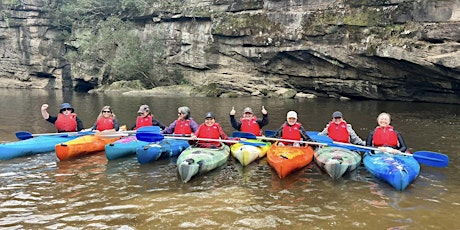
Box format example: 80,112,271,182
267,143,314,178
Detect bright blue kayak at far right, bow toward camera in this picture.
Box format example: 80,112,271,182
363,153,420,191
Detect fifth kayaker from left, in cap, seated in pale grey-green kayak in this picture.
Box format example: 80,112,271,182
192,112,228,148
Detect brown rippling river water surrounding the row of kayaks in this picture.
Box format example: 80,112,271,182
0,89,460,229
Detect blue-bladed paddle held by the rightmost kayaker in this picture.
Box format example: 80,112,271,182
309,135,449,168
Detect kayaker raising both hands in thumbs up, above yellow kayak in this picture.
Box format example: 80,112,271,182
230,106,268,136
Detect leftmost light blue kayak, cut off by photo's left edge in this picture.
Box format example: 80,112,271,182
0,134,80,160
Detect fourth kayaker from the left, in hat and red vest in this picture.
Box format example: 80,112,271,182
163,106,198,135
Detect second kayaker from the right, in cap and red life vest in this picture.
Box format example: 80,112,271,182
318,111,366,145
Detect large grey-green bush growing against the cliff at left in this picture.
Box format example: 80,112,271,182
67,17,164,87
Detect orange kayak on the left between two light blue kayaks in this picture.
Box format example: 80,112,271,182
55,135,120,161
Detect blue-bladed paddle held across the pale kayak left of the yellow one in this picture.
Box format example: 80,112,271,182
136,132,267,146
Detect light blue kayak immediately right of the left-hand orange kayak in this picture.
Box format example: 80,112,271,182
105,135,149,160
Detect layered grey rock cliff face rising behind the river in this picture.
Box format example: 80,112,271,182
0,0,460,104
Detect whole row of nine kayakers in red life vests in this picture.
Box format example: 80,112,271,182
41,103,407,153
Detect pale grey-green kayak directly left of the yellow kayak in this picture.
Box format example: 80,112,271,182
177,145,230,183
